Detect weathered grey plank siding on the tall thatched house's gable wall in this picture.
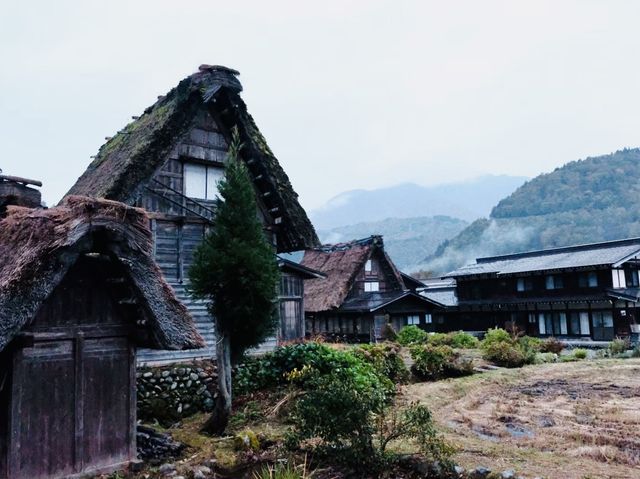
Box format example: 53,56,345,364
131,109,304,364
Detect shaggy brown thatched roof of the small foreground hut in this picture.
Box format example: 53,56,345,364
0,196,204,351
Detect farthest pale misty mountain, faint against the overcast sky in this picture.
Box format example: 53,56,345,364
309,175,527,230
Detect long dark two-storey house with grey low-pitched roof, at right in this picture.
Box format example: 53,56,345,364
440,238,640,341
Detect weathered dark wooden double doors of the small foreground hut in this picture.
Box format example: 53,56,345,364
9,337,135,479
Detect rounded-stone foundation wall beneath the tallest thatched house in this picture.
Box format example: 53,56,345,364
136,361,217,425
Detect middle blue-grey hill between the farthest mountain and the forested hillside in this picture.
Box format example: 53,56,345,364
318,216,469,271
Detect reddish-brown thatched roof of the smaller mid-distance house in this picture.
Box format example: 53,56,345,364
300,236,404,312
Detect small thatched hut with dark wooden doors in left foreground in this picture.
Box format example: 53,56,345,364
0,197,204,479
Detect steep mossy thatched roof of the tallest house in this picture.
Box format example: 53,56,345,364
67,65,319,251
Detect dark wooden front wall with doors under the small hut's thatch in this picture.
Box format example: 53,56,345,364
0,260,136,479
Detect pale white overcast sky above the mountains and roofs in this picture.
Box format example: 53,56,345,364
0,0,640,208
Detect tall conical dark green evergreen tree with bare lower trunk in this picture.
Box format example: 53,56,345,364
189,129,280,435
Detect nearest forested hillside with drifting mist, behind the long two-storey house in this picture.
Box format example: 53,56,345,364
420,148,640,274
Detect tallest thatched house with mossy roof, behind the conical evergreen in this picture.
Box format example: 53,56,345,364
68,65,318,362
